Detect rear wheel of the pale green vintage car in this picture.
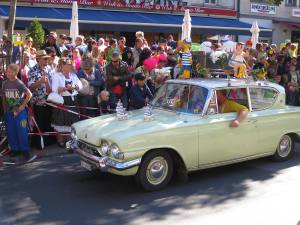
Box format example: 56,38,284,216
273,134,294,161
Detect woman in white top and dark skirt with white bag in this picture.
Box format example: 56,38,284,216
52,58,82,147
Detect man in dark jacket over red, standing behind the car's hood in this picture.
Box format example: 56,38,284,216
105,51,130,108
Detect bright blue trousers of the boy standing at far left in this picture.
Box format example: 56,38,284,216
4,109,30,152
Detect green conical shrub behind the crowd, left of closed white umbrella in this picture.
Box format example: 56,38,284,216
28,18,45,50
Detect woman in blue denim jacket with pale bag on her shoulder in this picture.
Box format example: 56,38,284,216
78,57,104,117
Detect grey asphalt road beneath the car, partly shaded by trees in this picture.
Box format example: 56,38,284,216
0,148,300,225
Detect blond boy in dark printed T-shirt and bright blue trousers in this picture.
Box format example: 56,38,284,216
2,64,32,160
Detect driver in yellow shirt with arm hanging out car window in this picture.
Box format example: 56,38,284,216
217,90,249,128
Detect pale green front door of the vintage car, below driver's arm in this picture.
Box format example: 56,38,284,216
199,88,257,167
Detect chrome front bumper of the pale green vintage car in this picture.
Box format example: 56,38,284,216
74,148,142,171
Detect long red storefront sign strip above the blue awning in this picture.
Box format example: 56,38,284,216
18,0,237,16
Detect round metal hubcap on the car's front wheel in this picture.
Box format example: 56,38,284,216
146,156,169,185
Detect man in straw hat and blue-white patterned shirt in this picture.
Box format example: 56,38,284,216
28,50,52,149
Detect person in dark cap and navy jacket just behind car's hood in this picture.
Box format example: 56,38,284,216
129,73,153,109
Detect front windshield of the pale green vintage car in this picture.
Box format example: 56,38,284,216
151,83,208,114
